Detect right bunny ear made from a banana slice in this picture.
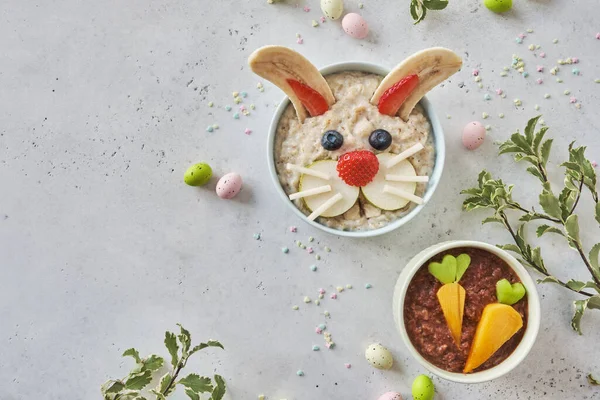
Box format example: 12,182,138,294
371,47,462,121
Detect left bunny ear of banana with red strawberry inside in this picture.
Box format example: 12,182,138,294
248,46,335,123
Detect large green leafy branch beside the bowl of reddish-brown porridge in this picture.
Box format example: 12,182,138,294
461,116,600,334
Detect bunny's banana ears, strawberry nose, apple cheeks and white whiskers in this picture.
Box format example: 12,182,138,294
249,46,462,225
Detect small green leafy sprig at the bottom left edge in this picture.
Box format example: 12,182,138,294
100,324,226,400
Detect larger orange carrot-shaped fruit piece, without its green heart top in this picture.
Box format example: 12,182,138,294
463,303,523,373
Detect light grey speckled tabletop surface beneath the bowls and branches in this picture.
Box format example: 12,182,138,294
0,0,600,400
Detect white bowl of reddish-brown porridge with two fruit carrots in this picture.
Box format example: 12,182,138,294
393,240,541,383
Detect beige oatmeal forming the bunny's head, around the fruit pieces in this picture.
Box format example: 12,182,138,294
274,72,435,231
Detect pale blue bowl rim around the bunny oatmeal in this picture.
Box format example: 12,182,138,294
267,62,446,237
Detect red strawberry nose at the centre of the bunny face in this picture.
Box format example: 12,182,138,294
337,150,379,186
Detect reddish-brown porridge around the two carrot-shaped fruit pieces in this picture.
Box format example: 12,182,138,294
404,248,527,372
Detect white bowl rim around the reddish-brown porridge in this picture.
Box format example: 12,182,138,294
393,240,541,383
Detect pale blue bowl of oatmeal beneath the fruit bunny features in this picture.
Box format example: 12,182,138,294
267,62,445,237
